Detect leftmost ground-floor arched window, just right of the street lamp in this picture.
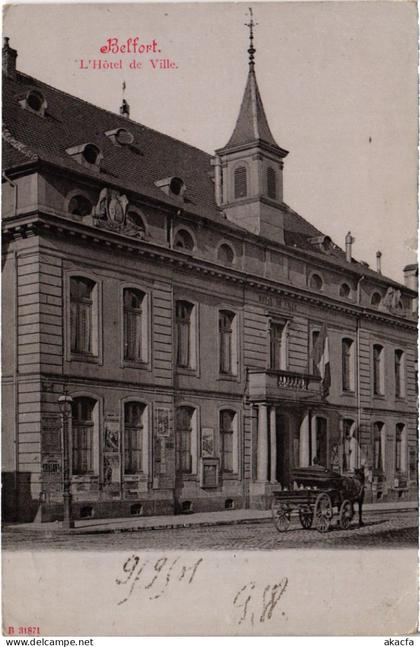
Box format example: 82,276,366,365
72,397,96,475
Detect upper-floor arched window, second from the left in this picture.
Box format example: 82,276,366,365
123,288,147,362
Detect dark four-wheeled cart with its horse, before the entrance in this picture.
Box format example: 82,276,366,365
271,466,363,533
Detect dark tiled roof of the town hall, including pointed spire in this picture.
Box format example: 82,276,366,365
3,69,410,287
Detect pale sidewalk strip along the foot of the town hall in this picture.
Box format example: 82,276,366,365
3,501,417,534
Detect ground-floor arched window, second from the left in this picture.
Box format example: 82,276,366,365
124,402,146,474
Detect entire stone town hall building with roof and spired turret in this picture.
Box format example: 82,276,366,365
2,35,417,520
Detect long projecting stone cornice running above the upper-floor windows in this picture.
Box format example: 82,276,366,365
3,211,417,332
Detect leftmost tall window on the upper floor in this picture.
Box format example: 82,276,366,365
70,276,97,354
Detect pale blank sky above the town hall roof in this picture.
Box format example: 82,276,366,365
3,1,418,281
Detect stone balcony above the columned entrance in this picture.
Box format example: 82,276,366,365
248,369,321,402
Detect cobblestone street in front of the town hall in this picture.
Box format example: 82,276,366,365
3,510,418,550
